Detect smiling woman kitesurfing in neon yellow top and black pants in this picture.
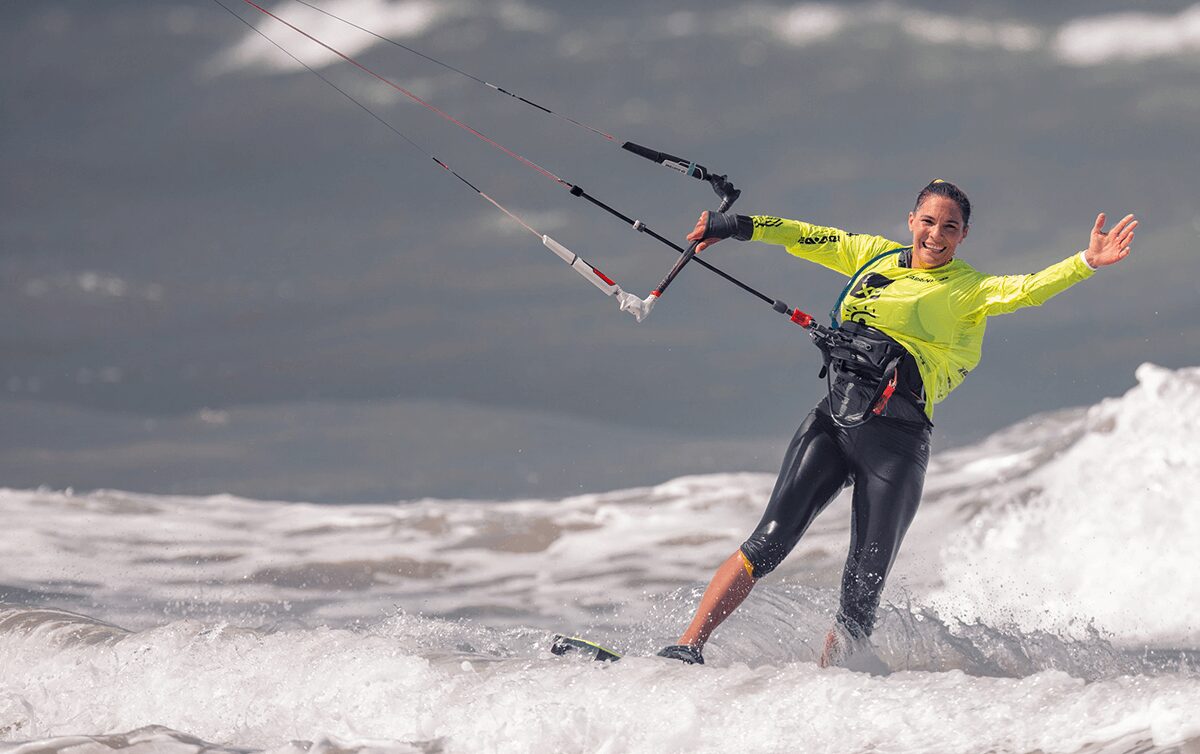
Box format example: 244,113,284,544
659,180,1138,666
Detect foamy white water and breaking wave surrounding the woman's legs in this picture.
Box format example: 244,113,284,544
0,365,1200,754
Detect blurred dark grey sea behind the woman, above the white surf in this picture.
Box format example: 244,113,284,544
0,0,1200,502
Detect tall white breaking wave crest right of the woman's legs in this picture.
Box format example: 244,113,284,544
931,365,1200,646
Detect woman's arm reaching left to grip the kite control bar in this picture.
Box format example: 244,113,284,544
688,211,902,276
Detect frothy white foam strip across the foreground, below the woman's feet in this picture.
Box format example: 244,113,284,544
0,607,1200,753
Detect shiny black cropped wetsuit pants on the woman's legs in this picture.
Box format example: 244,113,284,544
742,403,931,636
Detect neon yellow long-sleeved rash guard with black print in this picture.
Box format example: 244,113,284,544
750,215,1094,419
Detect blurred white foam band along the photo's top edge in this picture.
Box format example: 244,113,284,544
204,0,1200,82
